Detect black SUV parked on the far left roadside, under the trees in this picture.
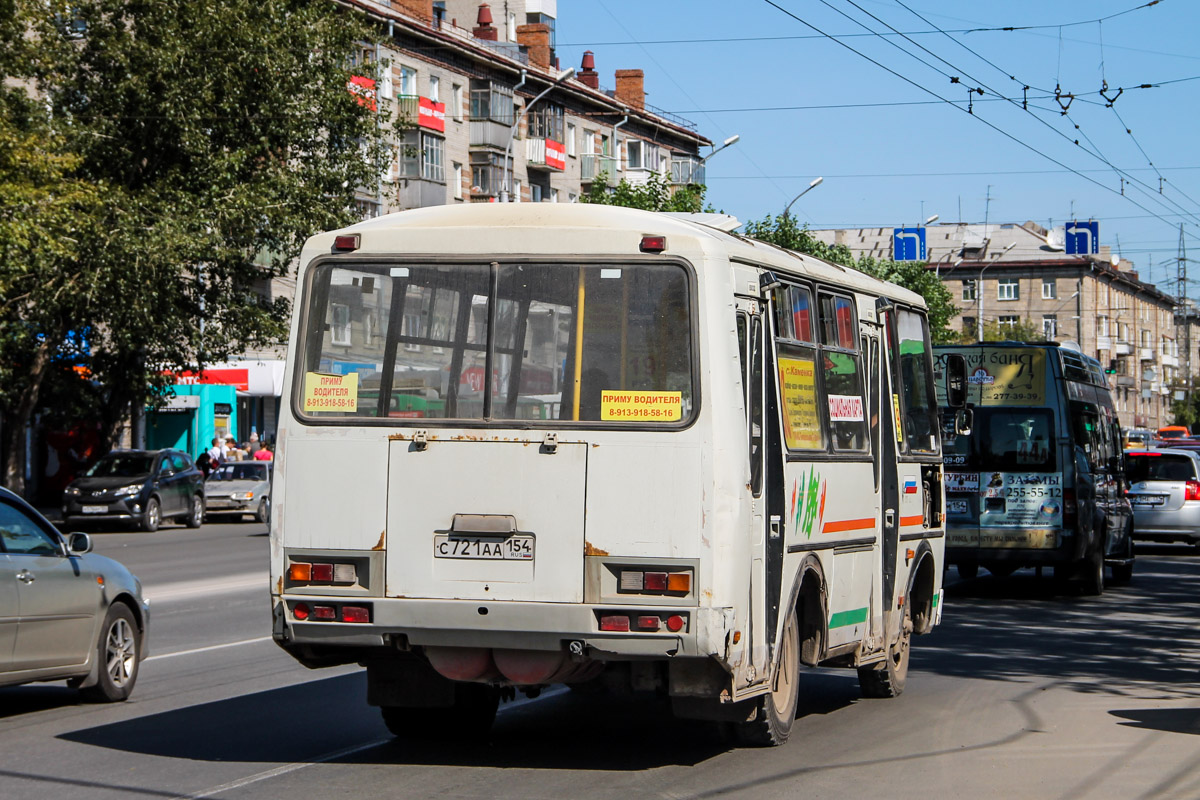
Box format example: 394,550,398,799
62,450,204,530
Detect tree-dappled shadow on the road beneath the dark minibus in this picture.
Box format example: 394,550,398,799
912,547,1200,698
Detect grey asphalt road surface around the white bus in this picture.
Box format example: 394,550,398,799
0,523,1200,800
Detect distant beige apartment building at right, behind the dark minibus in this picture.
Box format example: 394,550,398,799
811,222,1185,428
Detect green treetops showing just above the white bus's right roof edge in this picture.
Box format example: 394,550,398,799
744,216,959,344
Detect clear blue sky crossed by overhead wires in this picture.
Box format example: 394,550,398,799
557,0,1200,292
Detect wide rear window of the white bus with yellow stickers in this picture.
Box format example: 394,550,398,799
295,263,694,423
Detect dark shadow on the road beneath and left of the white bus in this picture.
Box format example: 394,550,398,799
60,673,728,771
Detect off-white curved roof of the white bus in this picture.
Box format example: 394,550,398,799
301,203,925,307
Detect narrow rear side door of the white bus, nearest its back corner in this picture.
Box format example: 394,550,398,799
737,297,778,682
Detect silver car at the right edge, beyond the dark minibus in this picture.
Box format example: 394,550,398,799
1126,447,1200,545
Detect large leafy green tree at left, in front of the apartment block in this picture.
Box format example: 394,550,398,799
0,0,388,494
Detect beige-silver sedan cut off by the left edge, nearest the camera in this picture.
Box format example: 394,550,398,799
0,488,150,703
